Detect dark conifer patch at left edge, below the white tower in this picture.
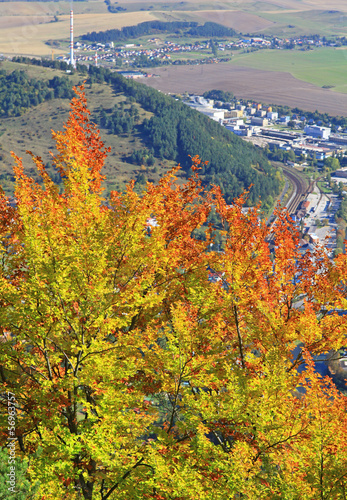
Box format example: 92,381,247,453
0,70,73,117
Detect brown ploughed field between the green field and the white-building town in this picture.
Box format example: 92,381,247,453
144,63,347,116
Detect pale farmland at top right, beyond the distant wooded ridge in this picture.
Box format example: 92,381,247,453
104,0,347,37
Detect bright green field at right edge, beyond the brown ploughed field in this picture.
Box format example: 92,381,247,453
231,46,347,93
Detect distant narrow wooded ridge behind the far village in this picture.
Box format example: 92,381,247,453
81,21,236,43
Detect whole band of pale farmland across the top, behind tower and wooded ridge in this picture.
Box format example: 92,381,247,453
0,0,347,56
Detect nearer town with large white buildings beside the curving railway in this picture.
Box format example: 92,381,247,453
183,95,347,258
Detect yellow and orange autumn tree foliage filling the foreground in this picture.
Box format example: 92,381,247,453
0,88,347,500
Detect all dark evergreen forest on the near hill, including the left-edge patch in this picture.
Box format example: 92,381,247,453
0,58,282,209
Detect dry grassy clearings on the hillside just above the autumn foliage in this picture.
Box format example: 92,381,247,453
0,63,173,193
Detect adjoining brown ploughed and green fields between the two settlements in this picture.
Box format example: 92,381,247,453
140,47,347,116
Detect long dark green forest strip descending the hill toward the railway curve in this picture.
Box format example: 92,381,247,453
89,67,281,205
